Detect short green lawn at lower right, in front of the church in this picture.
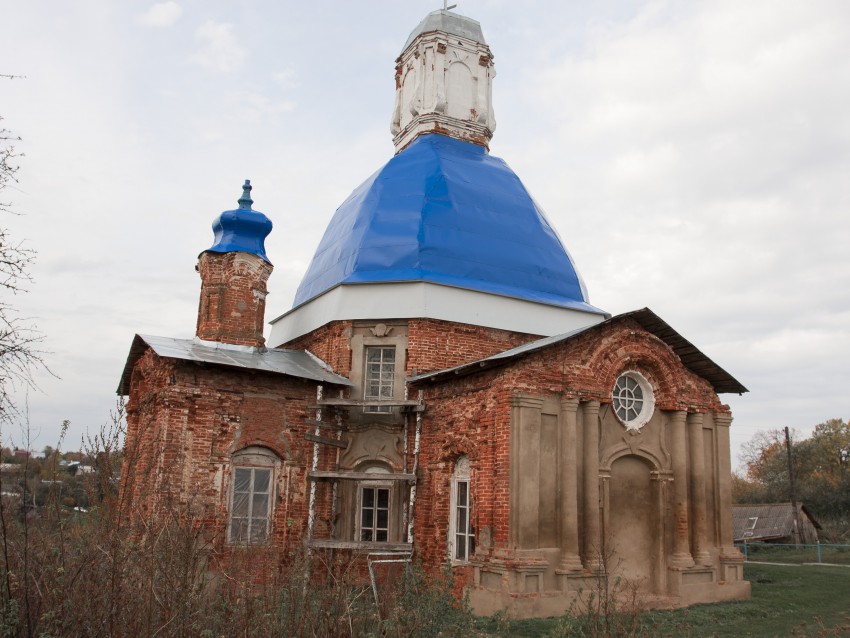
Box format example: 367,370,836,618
478,563,850,638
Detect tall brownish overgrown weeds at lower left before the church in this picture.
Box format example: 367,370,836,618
0,416,473,638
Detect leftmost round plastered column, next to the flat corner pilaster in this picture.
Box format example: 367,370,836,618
558,397,582,571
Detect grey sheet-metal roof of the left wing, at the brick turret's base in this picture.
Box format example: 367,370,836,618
118,334,352,396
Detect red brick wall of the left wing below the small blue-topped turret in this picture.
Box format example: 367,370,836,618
122,350,336,547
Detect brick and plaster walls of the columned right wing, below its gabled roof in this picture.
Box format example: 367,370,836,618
400,321,749,616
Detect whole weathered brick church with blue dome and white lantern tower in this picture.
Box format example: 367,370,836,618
118,10,750,617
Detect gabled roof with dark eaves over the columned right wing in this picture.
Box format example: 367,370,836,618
409,308,748,394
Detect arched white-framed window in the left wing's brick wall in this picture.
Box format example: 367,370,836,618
228,446,280,544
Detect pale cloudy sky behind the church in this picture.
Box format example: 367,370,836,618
0,0,850,470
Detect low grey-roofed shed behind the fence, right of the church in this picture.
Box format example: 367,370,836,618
732,503,820,544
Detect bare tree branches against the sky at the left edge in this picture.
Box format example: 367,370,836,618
0,74,47,421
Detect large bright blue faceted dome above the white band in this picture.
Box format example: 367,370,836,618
295,134,601,312
